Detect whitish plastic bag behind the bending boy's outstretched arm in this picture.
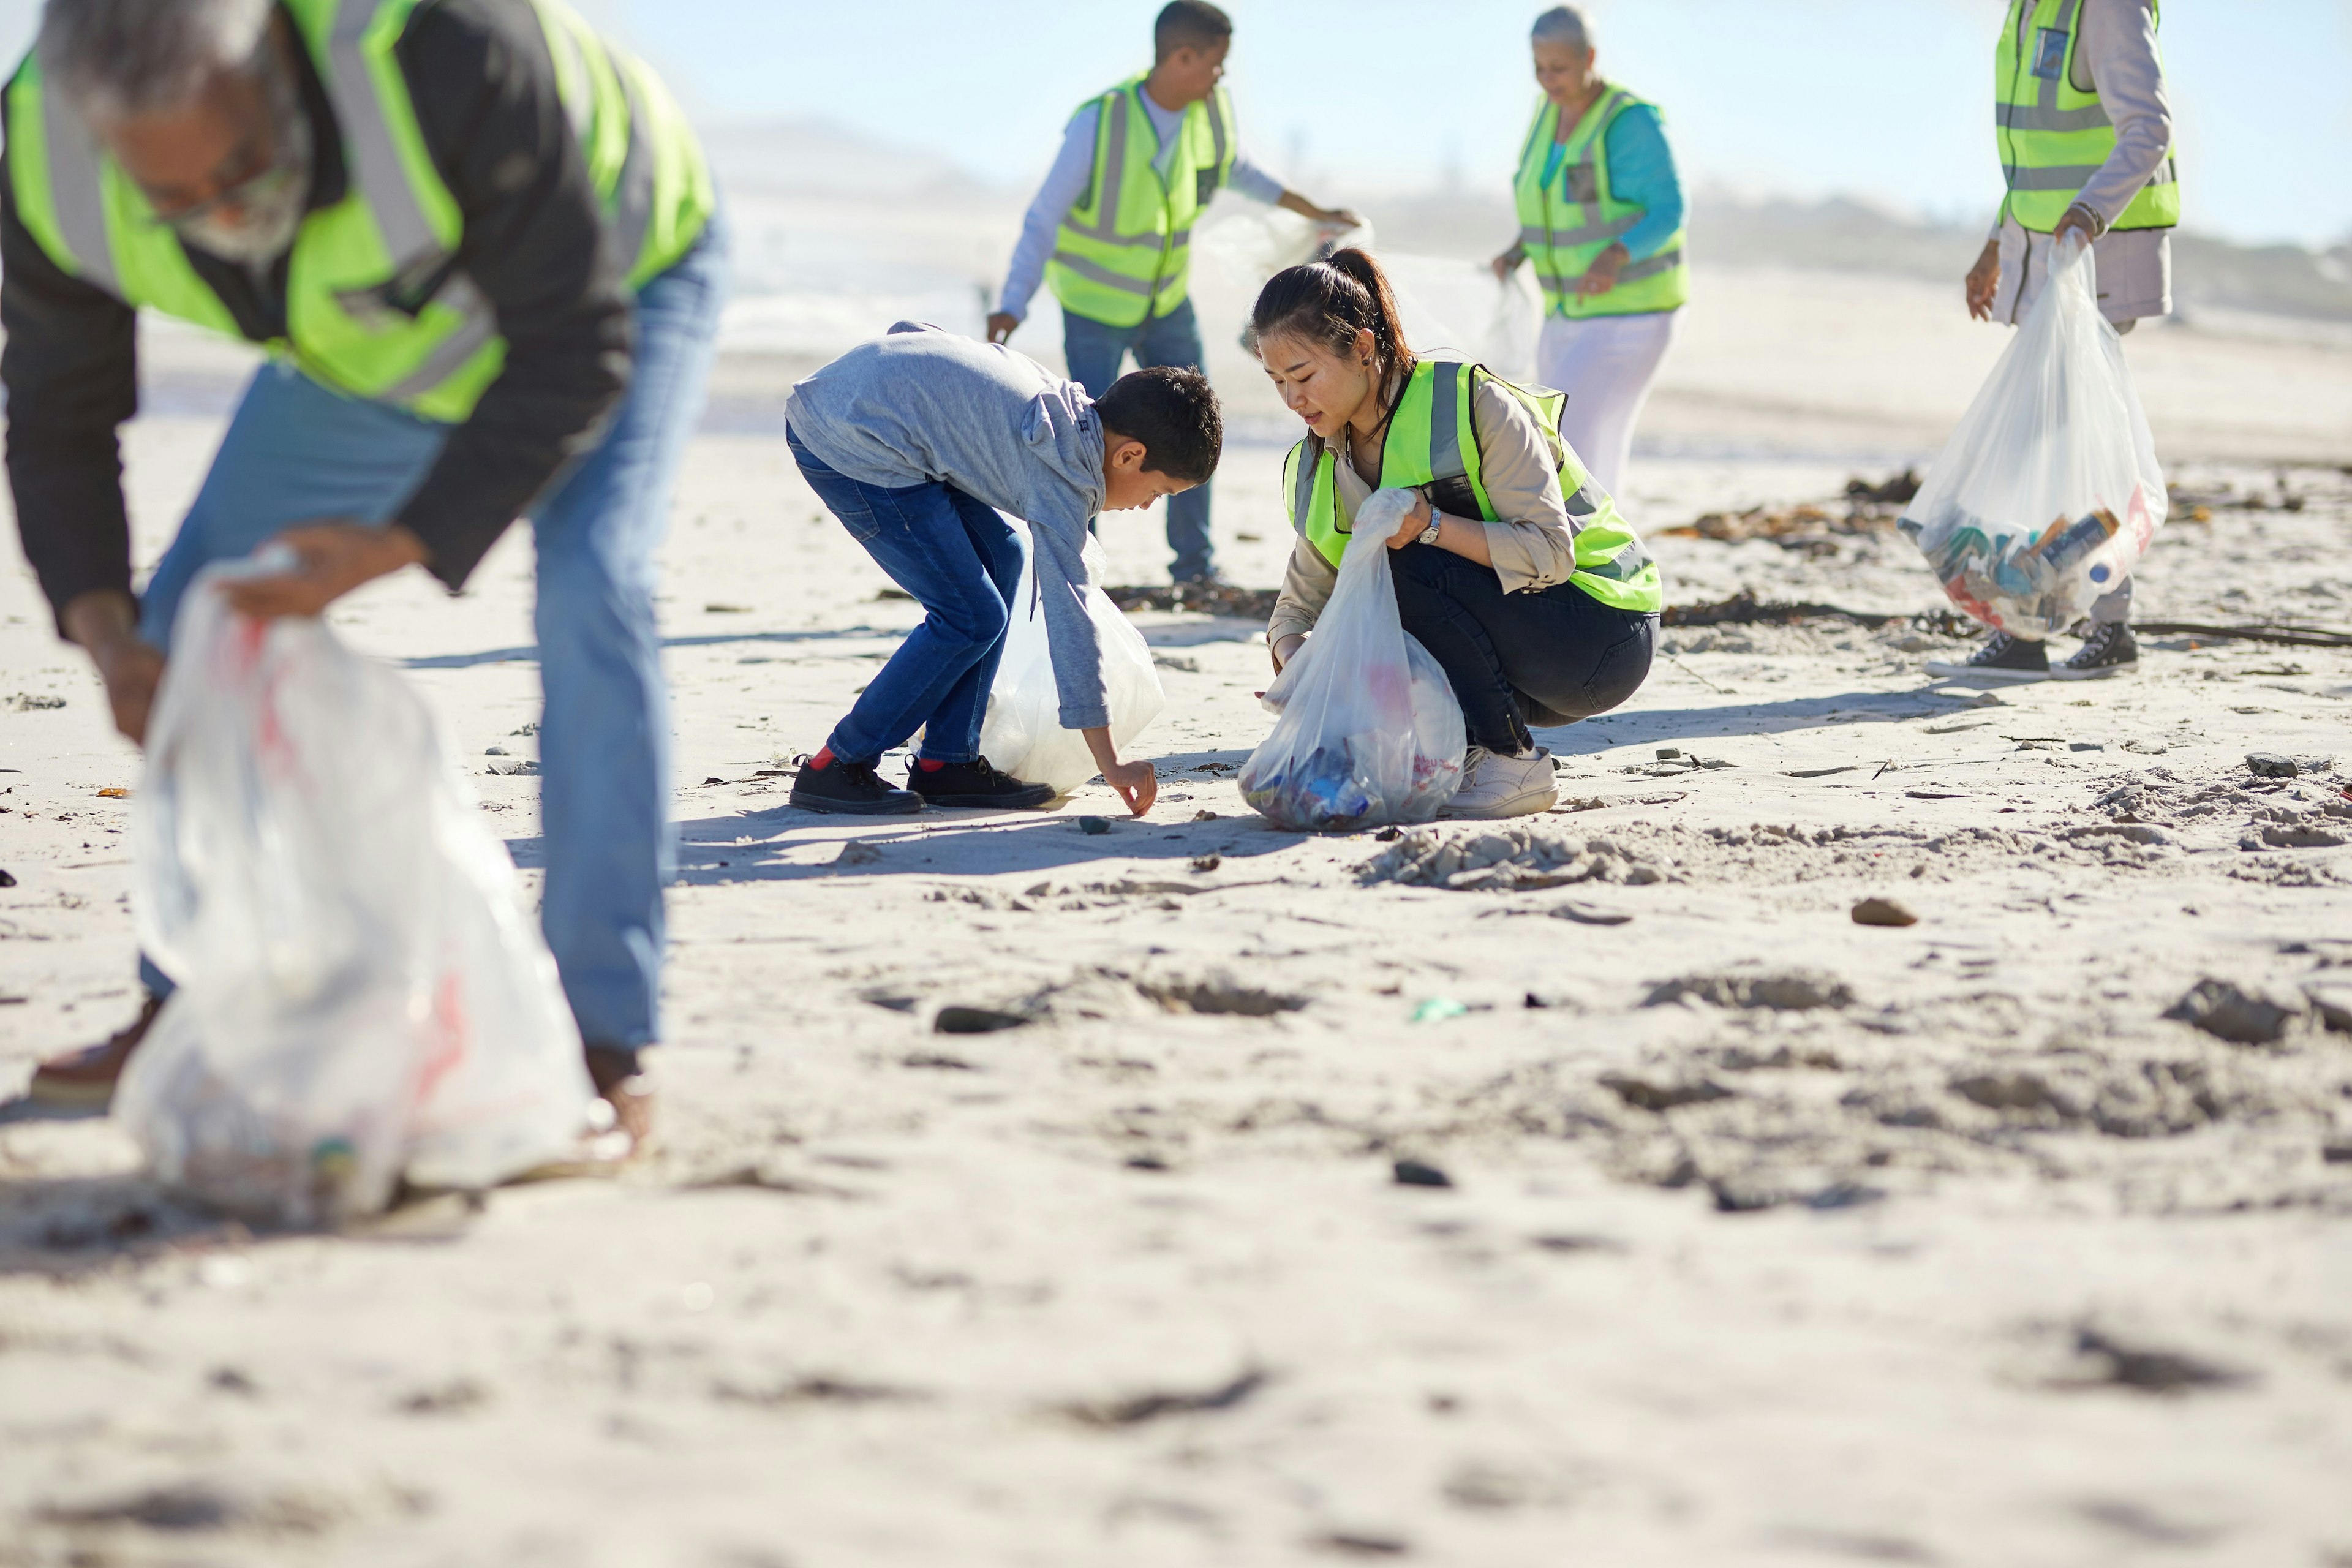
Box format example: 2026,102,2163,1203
981,517,1169,794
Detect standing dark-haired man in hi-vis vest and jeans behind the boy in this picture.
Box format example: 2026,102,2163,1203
988,0,1360,583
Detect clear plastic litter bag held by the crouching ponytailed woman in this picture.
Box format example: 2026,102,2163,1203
1240,489,1468,830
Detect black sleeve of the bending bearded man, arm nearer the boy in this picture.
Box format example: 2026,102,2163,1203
398,0,633,588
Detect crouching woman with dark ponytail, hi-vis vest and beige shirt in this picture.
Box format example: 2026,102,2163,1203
1249,249,1663,818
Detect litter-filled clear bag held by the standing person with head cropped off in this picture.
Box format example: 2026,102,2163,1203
1901,238,2166,642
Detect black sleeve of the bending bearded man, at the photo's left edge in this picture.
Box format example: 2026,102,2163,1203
0,83,139,630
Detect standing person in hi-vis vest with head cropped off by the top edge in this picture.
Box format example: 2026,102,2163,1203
1929,0,2180,679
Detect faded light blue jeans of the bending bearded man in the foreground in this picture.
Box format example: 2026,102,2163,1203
139,216,727,1051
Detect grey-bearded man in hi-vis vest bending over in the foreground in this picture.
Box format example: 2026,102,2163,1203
0,0,725,1145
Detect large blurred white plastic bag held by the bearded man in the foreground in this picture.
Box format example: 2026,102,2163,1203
115,557,593,1225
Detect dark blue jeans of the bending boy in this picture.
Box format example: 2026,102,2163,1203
783,430,1021,766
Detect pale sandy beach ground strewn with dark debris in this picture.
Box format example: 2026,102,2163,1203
0,251,2352,1568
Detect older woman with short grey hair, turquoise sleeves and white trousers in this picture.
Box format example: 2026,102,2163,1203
1493,5,1689,494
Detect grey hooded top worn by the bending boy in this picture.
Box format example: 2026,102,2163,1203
783,322,1110,729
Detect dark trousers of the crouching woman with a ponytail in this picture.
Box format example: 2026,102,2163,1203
1388,543,1658,752
